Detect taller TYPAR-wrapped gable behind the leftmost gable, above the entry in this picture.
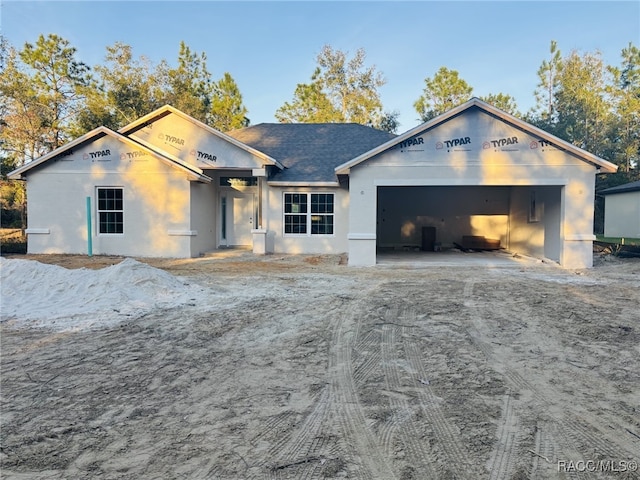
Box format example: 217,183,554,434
119,105,282,169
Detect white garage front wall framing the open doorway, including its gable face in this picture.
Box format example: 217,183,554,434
349,110,595,268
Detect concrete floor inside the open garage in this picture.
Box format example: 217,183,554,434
376,250,557,268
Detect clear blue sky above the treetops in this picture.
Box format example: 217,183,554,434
0,0,640,132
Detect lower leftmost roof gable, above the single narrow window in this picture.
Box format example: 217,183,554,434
8,127,211,183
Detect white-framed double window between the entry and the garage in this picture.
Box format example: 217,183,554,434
284,193,334,235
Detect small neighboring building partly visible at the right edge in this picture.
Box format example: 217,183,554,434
600,180,640,238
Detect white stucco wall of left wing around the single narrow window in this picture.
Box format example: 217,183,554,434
27,137,191,257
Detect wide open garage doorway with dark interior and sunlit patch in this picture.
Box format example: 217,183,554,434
376,186,562,262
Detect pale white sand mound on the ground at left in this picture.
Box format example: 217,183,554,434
0,258,203,330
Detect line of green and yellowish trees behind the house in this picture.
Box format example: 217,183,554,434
0,34,640,229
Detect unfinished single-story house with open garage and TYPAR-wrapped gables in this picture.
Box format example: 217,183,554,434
10,98,616,268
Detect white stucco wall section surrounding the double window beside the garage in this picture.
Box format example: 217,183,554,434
263,186,349,254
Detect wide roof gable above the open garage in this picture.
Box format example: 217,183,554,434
335,98,617,174
